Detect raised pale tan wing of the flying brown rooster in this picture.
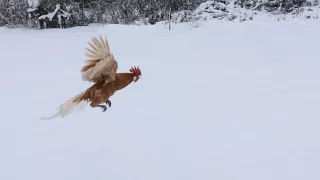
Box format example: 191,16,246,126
81,36,118,83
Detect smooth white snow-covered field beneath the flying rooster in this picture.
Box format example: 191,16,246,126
0,20,320,180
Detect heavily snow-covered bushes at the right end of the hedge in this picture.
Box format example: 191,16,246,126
172,0,320,22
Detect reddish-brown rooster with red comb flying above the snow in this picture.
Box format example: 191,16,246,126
42,36,141,119
